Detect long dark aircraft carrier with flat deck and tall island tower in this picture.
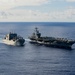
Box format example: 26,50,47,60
28,27,75,49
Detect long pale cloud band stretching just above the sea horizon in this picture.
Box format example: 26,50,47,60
0,8,75,22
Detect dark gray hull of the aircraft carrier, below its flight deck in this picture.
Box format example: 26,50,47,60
30,38,75,49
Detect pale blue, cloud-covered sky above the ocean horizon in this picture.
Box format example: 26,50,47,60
0,0,75,22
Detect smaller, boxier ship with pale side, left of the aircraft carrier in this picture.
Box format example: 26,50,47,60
2,32,25,46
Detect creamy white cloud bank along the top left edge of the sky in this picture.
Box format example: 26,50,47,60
0,0,48,10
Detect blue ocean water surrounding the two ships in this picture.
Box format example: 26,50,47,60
0,22,75,75
